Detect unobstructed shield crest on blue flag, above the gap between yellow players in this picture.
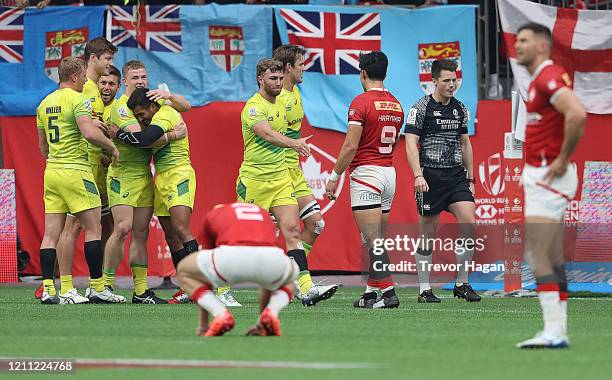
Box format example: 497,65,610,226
208,25,244,73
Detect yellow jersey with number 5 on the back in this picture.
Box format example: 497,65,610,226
36,88,91,170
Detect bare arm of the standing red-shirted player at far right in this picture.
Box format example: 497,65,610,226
544,89,586,183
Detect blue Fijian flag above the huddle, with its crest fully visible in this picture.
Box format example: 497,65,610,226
106,4,272,106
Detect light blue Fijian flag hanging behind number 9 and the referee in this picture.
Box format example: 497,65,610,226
275,5,478,134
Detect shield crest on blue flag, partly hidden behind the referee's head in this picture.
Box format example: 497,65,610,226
419,41,461,95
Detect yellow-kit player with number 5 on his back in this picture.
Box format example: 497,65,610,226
36,57,119,304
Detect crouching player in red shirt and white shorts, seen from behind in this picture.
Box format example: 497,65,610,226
177,203,299,337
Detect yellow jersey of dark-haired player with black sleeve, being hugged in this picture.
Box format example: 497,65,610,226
150,105,191,173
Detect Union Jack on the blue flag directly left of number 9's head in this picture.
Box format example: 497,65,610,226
280,9,381,75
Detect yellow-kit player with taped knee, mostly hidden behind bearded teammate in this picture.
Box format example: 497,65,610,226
273,45,338,305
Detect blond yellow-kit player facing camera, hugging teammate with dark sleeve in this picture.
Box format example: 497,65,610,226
104,61,191,304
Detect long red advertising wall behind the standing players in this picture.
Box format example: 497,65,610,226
0,101,612,275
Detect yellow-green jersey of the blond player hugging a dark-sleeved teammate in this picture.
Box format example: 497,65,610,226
105,94,151,177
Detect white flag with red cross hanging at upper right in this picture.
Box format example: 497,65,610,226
498,0,612,114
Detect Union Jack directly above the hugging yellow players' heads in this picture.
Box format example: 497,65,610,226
106,5,183,53
